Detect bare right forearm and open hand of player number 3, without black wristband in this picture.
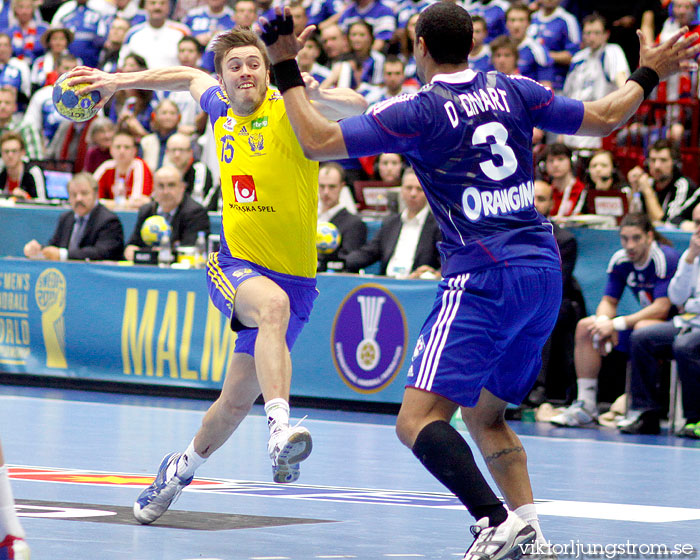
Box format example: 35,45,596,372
576,27,700,136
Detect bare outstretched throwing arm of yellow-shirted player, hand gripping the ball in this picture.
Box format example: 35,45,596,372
68,66,218,109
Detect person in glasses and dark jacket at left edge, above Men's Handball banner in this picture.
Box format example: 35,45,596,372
0,131,46,200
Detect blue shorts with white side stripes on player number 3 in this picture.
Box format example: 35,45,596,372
406,266,562,407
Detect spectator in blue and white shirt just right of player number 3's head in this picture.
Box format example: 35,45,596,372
506,3,554,87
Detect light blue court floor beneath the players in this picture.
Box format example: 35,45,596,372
0,387,700,560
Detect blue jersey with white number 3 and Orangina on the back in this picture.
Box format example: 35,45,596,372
340,70,583,276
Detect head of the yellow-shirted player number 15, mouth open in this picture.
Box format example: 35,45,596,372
219,46,268,116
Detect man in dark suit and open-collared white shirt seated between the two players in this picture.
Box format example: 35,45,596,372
345,167,441,278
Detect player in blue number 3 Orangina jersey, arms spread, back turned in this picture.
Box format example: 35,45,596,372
260,2,700,560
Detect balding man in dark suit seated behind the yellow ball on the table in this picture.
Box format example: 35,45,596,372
124,165,209,261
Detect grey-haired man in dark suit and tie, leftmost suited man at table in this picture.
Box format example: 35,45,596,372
24,173,124,261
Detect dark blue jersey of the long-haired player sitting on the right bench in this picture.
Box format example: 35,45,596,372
605,241,679,307
